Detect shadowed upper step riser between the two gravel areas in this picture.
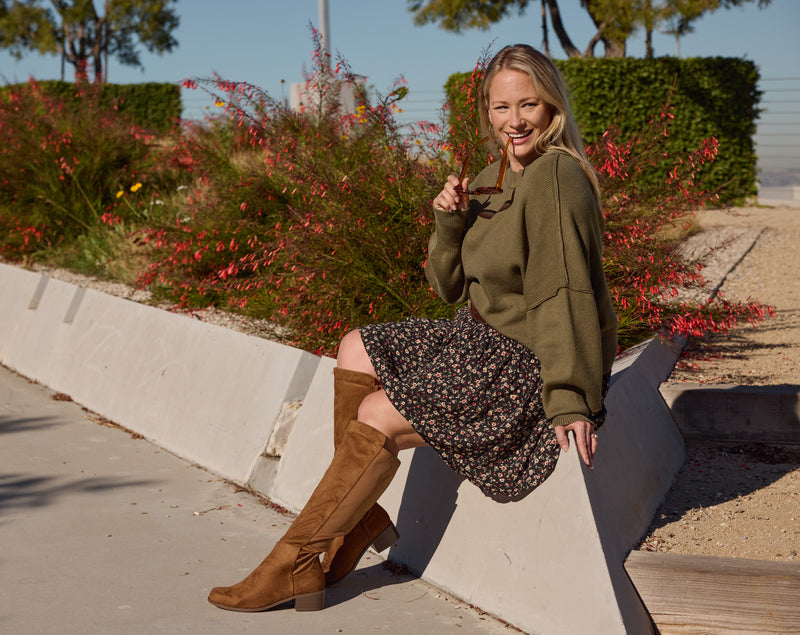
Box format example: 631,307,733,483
661,384,800,443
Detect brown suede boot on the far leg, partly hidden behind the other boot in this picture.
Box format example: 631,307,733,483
322,368,400,584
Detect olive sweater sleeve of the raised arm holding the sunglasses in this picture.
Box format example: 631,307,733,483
425,210,467,304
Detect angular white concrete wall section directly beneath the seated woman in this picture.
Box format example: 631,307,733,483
250,339,684,635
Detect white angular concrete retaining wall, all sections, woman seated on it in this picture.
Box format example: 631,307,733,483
0,266,684,635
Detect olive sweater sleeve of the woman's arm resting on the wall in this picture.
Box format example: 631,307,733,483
523,155,605,426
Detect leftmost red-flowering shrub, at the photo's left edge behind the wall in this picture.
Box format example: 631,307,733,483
0,80,189,260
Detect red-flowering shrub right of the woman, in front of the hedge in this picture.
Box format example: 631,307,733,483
587,109,771,346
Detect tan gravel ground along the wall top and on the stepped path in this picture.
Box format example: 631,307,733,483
23,202,800,561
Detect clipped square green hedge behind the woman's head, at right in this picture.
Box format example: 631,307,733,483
445,57,761,202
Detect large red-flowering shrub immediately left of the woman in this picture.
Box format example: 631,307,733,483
135,34,451,353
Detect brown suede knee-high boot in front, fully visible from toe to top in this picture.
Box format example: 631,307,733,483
208,420,400,612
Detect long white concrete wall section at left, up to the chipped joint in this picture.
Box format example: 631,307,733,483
0,265,319,482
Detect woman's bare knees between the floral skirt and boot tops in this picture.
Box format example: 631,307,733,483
336,330,426,454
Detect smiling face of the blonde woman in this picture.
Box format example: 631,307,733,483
487,69,552,171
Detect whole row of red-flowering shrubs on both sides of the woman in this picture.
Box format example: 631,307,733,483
0,39,766,353
